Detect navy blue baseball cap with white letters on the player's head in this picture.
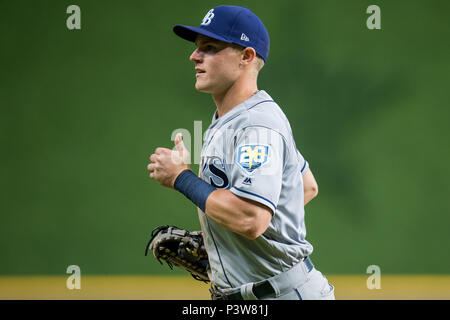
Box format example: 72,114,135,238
173,6,270,61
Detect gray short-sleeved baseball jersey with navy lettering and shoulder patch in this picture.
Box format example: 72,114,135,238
199,90,313,288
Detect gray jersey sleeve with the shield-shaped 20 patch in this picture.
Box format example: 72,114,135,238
230,127,286,213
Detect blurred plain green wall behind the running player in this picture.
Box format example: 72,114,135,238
0,0,450,275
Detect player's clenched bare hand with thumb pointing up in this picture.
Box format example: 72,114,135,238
147,133,191,188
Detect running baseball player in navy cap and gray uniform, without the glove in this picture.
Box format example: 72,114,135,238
148,6,334,300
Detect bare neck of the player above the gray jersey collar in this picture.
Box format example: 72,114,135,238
212,81,258,118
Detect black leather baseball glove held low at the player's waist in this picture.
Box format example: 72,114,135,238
145,226,210,282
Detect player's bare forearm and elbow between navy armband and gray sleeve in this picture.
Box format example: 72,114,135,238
205,189,271,239
